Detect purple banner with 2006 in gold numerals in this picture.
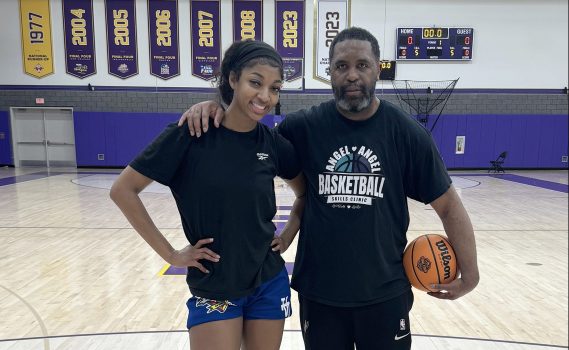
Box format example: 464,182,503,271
148,0,180,80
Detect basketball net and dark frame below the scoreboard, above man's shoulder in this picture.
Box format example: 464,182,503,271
393,78,459,131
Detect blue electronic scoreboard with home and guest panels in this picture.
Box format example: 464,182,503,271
395,27,474,61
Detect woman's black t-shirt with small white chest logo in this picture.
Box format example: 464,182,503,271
130,124,300,300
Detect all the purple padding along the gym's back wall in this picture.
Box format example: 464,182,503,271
0,111,569,169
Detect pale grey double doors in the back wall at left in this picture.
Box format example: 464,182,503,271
10,107,77,168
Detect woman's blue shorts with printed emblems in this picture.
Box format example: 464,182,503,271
186,268,292,329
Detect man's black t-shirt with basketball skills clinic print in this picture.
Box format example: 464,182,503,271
278,101,451,306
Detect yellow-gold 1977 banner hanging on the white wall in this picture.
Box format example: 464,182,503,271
20,0,53,78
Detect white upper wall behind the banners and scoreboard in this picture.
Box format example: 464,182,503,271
0,0,569,89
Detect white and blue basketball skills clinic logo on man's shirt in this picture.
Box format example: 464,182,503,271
318,146,385,205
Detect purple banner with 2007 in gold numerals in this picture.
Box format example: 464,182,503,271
190,0,221,80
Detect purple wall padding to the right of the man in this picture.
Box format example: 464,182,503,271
428,115,569,169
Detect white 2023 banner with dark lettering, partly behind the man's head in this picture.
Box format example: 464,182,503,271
314,0,350,84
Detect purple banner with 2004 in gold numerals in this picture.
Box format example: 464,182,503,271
62,0,97,79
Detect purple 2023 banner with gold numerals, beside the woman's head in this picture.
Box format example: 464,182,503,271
275,0,304,81
